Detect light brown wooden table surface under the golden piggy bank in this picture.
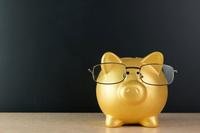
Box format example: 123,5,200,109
0,113,200,133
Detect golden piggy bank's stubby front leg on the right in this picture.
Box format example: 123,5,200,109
140,116,158,127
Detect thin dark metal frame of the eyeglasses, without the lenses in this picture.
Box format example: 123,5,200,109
88,62,178,86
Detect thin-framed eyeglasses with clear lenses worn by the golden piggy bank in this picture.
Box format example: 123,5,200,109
88,62,178,86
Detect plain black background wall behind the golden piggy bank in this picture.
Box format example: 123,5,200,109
0,0,200,112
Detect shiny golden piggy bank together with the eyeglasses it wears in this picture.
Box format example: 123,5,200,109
89,52,176,127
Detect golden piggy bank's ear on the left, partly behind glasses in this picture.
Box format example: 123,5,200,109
101,52,122,73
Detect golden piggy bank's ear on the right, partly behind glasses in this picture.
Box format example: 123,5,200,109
141,52,164,74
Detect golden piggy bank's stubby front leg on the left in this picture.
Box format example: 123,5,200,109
105,115,124,127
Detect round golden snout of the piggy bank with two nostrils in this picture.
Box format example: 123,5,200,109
119,81,147,104
